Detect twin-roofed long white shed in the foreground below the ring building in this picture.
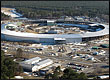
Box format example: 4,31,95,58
20,57,53,72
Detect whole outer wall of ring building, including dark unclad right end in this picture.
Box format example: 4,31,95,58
1,34,106,44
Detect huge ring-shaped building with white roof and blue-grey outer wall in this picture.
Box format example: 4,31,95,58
1,23,109,44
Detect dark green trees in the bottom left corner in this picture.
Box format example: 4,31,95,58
1,50,23,79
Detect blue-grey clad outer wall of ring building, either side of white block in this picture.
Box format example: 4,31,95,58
1,34,82,43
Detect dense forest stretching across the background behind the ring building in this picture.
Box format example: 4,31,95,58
1,1,109,18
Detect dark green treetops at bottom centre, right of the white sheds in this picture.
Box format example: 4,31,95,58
45,66,87,80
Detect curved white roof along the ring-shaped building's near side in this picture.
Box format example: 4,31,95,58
1,24,109,38
